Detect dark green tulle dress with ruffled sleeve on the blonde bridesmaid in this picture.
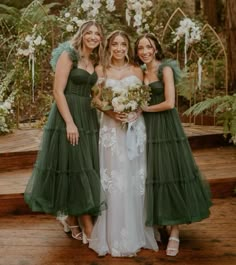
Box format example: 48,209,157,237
24,44,105,216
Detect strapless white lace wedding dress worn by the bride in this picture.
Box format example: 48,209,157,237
89,75,158,257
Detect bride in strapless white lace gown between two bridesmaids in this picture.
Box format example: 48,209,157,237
89,31,158,257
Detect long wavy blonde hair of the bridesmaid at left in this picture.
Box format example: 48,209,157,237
71,20,104,65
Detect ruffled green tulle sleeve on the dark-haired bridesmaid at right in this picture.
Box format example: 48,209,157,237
157,59,182,84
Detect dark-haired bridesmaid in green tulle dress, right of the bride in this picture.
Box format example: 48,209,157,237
135,33,211,256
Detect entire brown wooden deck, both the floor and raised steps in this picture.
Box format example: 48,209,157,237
0,125,236,265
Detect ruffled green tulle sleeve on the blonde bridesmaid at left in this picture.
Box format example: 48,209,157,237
50,41,78,72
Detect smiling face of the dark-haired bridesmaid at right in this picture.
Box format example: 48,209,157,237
137,37,156,64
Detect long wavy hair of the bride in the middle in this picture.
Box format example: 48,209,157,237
104,30,133,70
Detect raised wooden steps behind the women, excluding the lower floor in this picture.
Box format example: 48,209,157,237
0,125,236,216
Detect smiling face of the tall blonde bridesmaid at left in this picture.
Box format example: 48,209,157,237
83,25,102,50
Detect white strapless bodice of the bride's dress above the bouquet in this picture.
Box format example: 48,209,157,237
105,75,142,89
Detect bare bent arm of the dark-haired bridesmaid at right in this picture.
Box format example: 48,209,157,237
142,66,175,112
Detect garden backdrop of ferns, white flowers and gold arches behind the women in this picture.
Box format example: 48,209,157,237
0,0,236,143
